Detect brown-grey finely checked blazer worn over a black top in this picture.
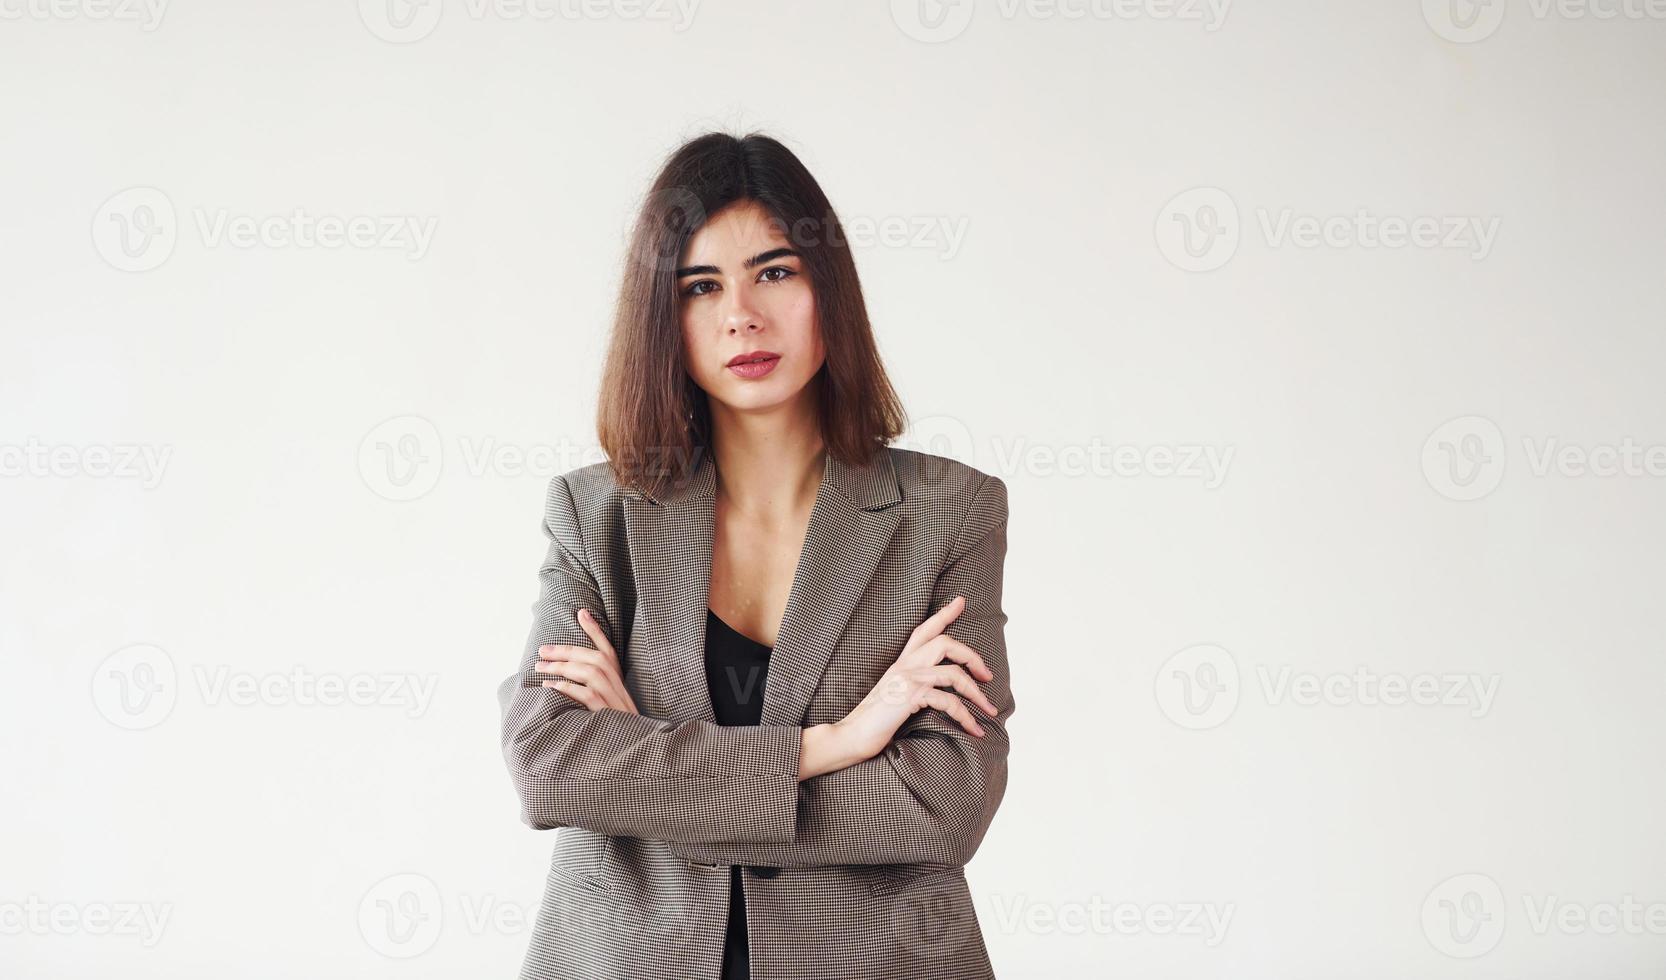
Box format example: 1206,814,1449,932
498,448,1015,980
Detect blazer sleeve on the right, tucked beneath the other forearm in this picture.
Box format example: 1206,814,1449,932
671,477,1015,868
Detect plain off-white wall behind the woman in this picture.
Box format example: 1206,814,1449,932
0,0,1666,978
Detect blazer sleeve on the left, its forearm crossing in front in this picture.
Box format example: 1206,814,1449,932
498,477,803,843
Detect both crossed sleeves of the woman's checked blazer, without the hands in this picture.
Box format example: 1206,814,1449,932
498,477,1013,867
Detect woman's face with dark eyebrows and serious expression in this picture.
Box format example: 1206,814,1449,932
676,202,826,415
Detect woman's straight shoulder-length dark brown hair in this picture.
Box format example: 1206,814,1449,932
596,133,905,497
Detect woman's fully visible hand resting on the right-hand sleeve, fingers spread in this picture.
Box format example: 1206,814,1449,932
806,595,998,772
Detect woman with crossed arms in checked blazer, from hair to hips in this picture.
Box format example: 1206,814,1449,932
500,133,1013,980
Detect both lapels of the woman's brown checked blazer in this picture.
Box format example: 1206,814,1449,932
625,447,901,725
